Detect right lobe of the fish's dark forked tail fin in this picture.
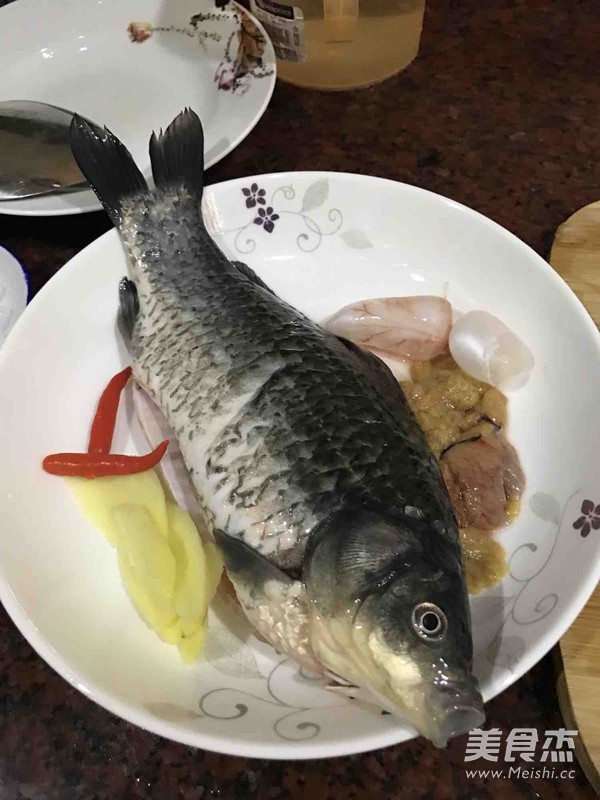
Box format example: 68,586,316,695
150,108,204,202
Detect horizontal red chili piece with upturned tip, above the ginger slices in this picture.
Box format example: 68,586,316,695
43,440,169,478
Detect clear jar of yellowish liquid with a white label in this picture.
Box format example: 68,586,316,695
250,0,425,89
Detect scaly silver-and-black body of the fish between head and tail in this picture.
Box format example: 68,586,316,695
124,189,452,568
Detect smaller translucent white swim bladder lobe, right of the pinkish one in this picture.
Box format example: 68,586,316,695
449,311,534,391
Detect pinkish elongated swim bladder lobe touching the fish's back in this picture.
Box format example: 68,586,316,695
325,295,452,361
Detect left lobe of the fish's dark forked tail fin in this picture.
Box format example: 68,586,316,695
69,114,148,226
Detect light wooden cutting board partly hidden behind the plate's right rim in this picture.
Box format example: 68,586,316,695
550,202,600,794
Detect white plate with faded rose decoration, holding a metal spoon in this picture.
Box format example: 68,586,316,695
0,0,275,216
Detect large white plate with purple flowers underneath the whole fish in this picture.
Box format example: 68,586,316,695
0,173,600,759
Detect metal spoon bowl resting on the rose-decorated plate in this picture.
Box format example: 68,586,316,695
0,100,88,201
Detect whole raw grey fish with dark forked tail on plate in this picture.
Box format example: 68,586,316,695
71,109,484,746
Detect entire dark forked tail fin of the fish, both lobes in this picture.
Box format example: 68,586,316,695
69,108,204,226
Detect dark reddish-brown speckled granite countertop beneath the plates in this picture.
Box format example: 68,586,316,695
0,0,600,800
